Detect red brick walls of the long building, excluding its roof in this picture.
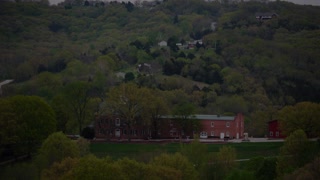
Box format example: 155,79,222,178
95,114,244,139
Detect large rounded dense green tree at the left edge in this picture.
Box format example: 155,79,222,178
0,96,56,155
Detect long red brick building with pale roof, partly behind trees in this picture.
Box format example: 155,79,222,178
95,113,244,139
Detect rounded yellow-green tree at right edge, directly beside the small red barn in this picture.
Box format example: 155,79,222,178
278,102,320,137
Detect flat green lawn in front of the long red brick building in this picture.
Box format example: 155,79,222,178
90,142,283,161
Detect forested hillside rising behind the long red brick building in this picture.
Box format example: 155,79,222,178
0,0,320,136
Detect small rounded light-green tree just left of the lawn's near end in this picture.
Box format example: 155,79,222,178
36,132,80,169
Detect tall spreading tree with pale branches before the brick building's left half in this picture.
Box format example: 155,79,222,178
105,83,150,141
